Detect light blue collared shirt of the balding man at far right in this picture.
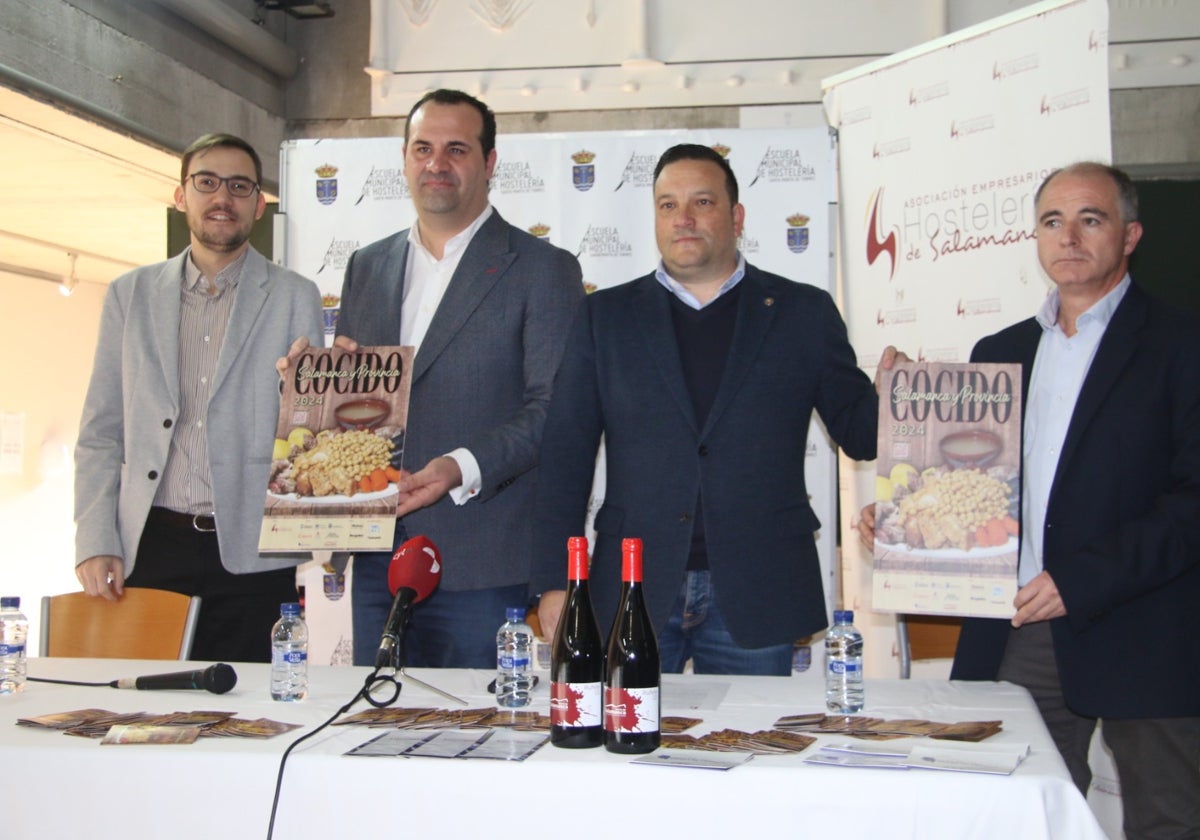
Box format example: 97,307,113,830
1018,274,1130,587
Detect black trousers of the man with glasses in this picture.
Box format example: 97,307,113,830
125,508,296,662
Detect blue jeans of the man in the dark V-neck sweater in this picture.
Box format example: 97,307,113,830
659,571,792,677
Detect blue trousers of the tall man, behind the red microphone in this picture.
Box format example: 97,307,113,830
350,523,528,670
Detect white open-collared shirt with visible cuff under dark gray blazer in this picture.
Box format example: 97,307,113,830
400,204,492,504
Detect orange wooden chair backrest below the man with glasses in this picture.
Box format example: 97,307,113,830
38,587,200,659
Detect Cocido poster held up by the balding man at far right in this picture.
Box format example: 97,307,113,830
872,362,1021,618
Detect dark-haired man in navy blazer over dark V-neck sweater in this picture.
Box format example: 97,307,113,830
530,144,878,674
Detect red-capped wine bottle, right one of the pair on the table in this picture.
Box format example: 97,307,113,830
604,540,662,752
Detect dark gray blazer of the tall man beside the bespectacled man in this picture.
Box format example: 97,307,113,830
337,211,583,590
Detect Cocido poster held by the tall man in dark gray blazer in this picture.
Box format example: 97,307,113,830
259,347,414,552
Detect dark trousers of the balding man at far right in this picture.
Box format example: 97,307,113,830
997,622,1200,840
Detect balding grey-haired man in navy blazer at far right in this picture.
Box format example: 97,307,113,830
952,163,1200,838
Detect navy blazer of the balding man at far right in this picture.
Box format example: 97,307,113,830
952,286,1200,718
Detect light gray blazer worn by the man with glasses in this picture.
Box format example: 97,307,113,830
74,248,324,576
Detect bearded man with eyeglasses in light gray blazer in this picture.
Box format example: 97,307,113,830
76,134,324,661
